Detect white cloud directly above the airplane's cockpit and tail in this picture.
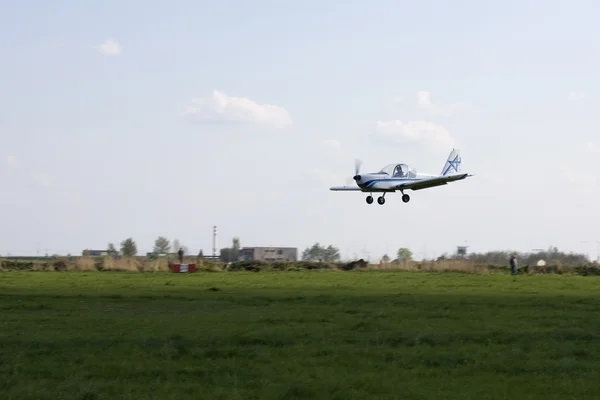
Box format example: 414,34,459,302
375,120,455,148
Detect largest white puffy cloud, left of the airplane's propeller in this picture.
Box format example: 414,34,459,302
184,90,292,127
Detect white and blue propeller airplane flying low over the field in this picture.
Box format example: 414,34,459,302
329,149,473,204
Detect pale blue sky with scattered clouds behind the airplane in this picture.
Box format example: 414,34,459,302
0,0,600,261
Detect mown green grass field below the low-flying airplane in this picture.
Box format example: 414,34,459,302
0,271,600,400
